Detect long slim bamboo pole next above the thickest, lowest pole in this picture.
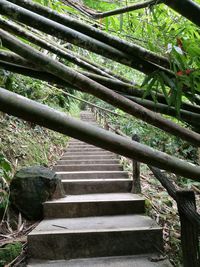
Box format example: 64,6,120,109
0,29,200,146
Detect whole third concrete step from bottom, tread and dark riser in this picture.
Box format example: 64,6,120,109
43,193,145,218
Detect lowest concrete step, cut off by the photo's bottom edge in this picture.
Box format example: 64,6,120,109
27,254,172,267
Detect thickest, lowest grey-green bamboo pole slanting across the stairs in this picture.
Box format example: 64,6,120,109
0,88,200,181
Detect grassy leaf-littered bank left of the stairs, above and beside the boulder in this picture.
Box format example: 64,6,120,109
0,114,68,224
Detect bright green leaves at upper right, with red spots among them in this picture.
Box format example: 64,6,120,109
81,0,200,111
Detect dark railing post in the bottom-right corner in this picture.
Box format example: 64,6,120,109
176,191,200,267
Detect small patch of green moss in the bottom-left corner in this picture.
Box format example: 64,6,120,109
0,242,22,267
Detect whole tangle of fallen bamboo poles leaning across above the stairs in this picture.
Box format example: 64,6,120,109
0,0,200,180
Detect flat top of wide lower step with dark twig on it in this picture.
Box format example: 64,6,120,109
29,214,161,236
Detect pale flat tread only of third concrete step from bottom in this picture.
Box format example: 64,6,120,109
45,193,144,204
